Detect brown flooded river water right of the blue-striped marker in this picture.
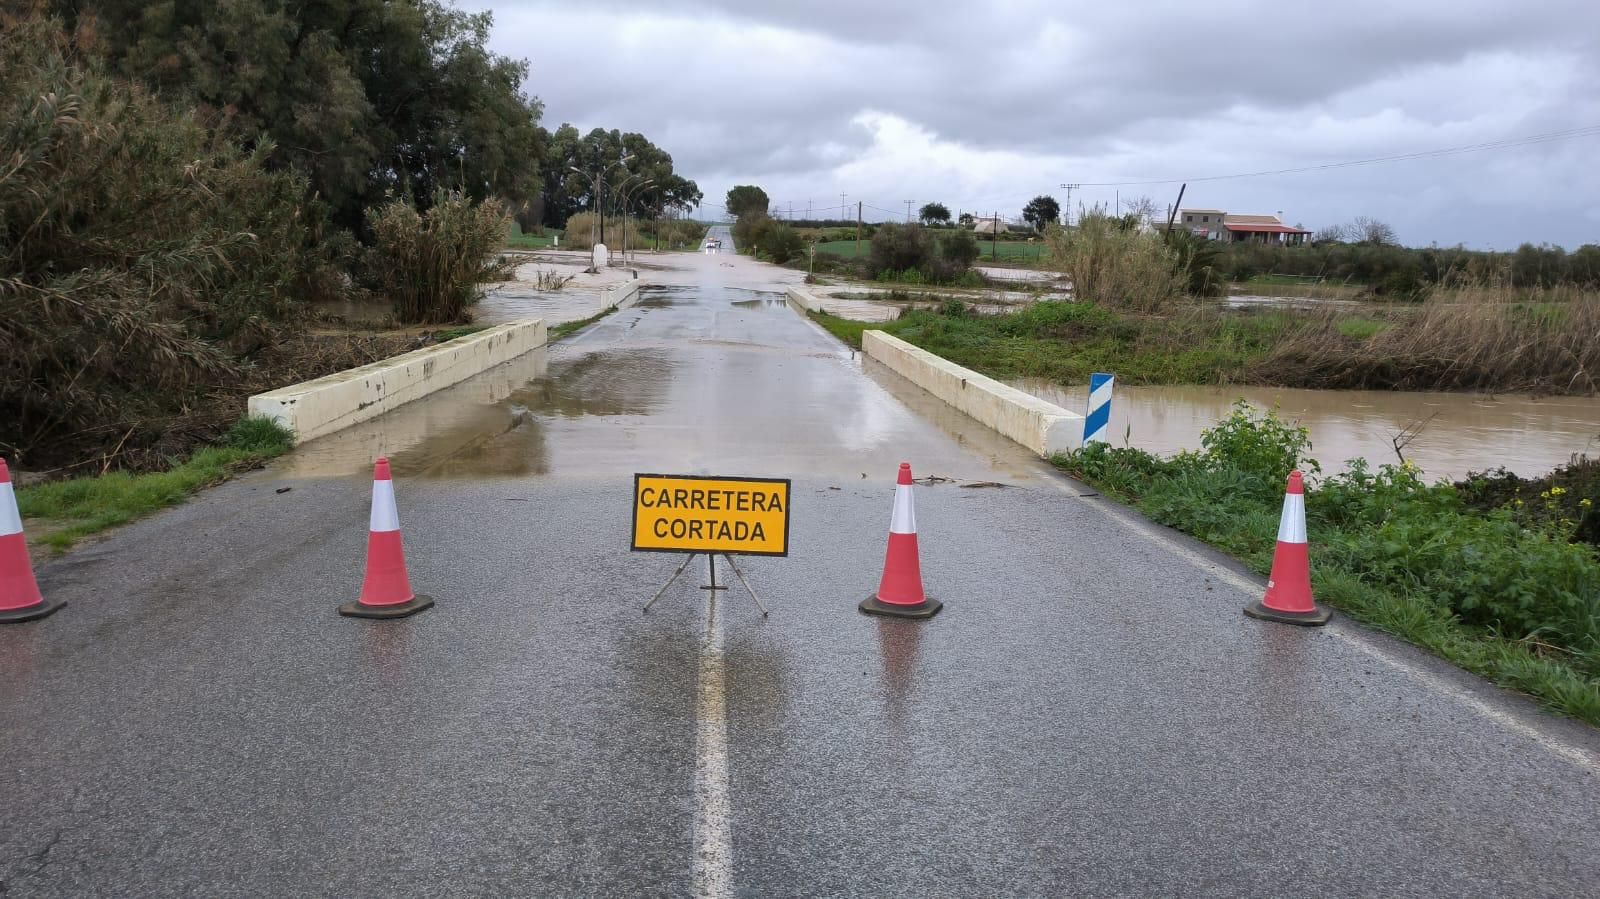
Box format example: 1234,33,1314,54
1011,379,1600,478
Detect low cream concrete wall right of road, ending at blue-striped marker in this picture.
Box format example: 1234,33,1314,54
861,331,1083,457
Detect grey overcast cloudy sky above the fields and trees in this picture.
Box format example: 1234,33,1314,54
462,0,1600,248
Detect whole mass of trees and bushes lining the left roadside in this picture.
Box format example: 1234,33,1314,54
0,0,699,462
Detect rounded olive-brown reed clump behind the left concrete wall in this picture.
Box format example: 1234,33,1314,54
366,194,509,325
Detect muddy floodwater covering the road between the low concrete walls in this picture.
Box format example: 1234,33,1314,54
280,276,1049,483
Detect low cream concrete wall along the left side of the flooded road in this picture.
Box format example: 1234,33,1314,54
248,316,547,442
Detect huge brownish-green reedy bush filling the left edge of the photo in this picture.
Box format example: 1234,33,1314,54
0,19,331,469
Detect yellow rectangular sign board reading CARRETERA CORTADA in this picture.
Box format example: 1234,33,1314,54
634,475,789,555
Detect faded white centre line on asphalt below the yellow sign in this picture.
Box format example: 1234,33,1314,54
693,572,733,899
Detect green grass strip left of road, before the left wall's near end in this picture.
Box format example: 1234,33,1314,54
16,418,294,552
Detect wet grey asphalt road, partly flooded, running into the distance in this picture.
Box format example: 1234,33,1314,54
0,228,1600,896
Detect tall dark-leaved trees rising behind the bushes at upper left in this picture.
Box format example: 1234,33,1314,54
54,0,542,226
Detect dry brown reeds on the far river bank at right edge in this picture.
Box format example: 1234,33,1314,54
1259,285,1600,394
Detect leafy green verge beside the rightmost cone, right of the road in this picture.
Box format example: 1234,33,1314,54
1054,403,1600,725
